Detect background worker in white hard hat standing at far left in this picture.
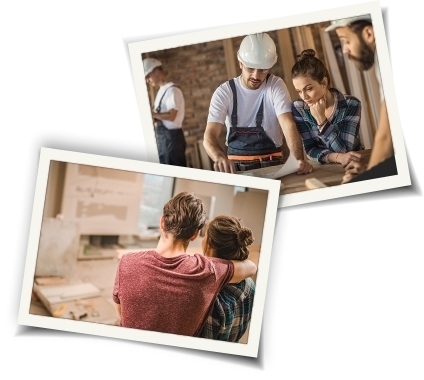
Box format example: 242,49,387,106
143,58,187,166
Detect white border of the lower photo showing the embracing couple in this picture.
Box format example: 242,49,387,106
18,148,280,357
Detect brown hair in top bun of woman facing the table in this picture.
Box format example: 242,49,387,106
292,49,330,87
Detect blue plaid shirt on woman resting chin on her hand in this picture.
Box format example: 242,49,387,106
292,88,364,163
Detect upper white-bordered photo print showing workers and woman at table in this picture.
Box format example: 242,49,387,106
126,2,411,208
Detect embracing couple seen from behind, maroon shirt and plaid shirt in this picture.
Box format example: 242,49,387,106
113,192,257,342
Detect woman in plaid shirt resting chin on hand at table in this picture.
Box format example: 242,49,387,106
291,49,364,167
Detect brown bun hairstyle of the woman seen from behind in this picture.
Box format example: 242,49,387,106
206,215,255,260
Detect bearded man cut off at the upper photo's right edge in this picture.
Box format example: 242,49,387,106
325,15,397,183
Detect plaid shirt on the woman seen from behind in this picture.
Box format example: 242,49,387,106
199,278,255,342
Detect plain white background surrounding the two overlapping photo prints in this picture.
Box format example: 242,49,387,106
0,0,424,380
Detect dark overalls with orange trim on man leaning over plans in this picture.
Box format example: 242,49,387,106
227,74,284,171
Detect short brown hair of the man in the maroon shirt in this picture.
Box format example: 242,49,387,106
163,192,206,242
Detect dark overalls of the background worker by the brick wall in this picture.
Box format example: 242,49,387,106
155,85,187,166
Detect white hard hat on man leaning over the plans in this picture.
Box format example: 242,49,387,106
237,33,277,69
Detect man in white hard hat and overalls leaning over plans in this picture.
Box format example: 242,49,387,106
203,33,312,174
